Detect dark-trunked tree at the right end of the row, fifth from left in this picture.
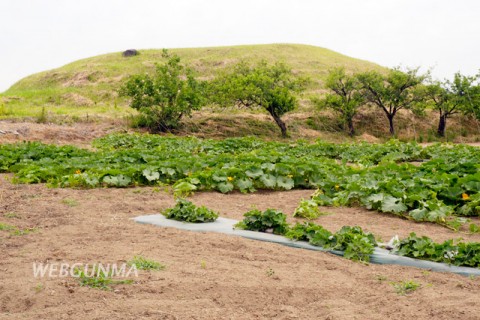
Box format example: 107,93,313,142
423,73,476,137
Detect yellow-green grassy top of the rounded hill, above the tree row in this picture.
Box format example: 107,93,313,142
0,44,383,118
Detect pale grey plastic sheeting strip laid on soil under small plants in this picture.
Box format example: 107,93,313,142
133,214,480,276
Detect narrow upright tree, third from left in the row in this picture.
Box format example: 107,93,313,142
313,68,365,136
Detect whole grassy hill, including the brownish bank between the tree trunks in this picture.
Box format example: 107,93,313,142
0,44,480,141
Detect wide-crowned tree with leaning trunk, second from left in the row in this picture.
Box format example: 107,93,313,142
210,61,305,137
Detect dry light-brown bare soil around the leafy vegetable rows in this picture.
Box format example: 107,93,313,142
0,121,480,320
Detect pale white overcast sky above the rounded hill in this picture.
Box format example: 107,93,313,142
0,0,480,92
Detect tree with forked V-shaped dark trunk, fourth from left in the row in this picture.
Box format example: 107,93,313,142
357,69,426,135
